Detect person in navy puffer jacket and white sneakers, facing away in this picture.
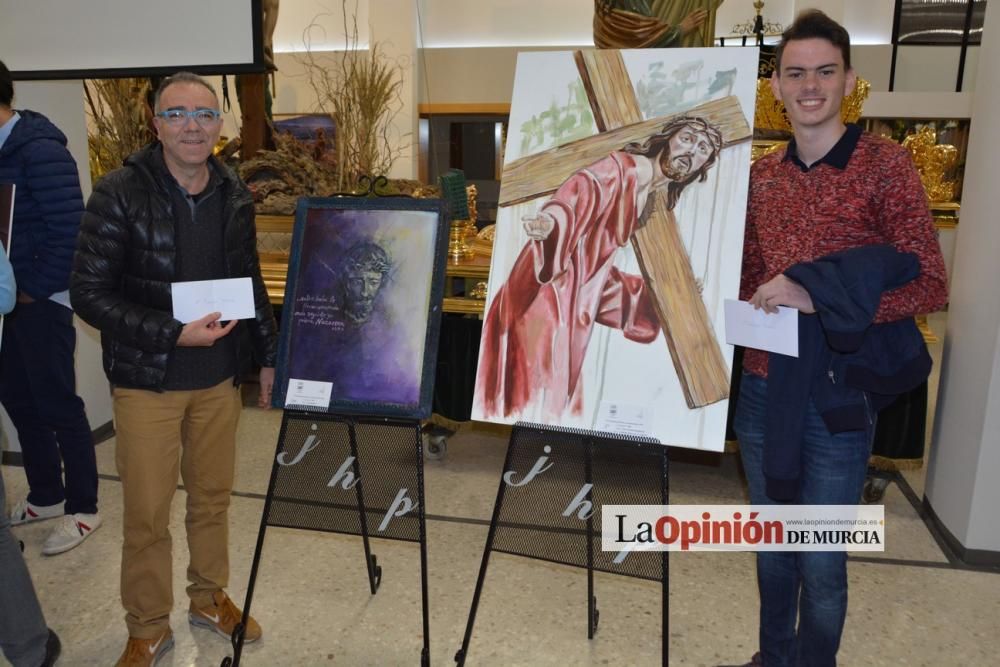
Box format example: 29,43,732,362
0,57,101,556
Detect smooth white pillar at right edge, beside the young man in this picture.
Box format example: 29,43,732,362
925,1,1000,552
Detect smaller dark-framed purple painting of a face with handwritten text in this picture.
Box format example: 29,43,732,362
275,197,448,417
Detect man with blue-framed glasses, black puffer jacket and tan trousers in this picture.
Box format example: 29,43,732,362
71,72,277,665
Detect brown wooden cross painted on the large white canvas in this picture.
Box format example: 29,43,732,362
500,51,752,408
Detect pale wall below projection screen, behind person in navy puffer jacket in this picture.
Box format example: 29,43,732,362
2,81,111,451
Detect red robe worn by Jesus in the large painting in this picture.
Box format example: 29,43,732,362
476,152,660,418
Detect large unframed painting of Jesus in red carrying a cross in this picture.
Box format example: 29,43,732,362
473,49,757,450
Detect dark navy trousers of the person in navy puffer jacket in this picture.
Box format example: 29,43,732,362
0,299,97,514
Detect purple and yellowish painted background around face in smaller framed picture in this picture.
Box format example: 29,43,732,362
285,209,437,404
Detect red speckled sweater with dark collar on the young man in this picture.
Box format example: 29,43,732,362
740,126,948,377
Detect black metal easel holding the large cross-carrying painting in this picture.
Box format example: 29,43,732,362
455,423,669,666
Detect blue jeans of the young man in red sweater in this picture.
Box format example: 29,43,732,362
733,373,874,667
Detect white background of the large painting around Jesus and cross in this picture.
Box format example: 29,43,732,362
472,49,757,451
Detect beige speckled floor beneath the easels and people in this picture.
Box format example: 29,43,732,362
0,314,1000,667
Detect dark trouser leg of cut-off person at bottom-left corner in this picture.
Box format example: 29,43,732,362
0,474,49,667
